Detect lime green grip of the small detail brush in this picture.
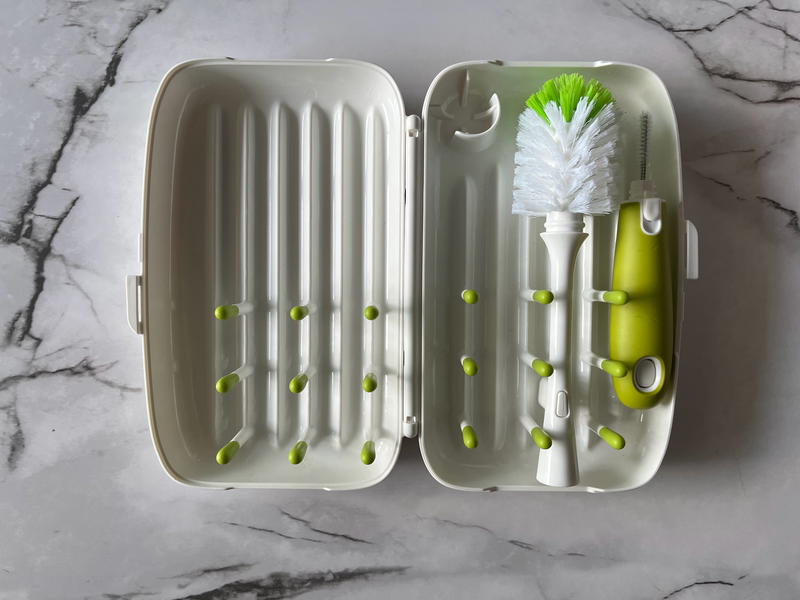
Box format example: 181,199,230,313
609,202,675,409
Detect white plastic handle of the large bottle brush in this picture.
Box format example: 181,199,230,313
536,213,587,487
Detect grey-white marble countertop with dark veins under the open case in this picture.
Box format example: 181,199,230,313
0,0,800,600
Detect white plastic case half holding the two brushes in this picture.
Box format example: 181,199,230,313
420,61,686,491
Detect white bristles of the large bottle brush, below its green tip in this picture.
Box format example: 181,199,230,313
511,97,619,217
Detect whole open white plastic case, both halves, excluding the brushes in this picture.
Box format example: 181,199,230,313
128,59,697,491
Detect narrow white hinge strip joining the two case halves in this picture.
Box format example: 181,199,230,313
403,115,422,437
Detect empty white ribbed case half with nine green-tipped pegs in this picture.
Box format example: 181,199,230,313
135,60,414,489
